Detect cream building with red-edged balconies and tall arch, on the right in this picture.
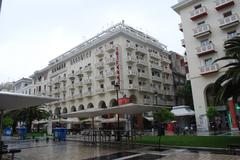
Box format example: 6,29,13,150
172,0,240,131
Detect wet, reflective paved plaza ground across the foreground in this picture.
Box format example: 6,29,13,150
1,140,240,160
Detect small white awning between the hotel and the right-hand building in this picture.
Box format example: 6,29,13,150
171,106,195,117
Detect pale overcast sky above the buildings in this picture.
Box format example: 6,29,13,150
0,0,184,82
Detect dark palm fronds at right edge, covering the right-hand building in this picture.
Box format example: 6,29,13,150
214,35,240,104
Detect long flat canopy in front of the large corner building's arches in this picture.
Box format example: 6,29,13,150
61,103,161,118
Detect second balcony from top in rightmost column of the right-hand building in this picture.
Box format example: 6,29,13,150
219,14,239,29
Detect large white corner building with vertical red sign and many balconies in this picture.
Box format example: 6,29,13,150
15,22,175,129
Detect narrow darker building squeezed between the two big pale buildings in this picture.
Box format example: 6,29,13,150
169,51,187,106
